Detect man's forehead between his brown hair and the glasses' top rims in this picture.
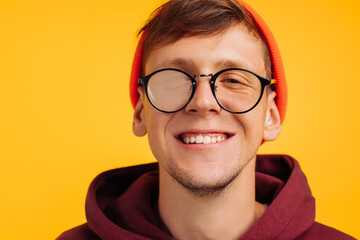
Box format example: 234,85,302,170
144,24,265,75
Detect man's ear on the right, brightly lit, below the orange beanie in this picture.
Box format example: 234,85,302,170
264,91,281,141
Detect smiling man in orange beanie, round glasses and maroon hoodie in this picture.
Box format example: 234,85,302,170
58,0,353,240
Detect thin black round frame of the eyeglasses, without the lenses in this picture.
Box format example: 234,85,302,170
139,68,276,114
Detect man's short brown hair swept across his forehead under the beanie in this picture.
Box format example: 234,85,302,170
138,0,271,78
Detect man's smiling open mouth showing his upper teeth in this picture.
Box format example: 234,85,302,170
180,133,229,144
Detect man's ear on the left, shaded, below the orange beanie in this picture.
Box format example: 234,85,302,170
133,87,147,137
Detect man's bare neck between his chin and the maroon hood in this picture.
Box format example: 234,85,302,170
159,159,264,240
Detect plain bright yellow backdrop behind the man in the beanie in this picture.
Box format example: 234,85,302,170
0,0,360,240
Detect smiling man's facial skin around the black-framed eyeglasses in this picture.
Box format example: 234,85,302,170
134,24,280,193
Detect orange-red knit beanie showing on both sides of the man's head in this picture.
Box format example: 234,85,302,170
130,0,287,123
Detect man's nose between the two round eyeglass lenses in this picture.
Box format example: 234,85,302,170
185,74,221,114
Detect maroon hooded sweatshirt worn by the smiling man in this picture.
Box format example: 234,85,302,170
57,155,354,240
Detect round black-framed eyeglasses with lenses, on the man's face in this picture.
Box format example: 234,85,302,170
139,68,275,114
